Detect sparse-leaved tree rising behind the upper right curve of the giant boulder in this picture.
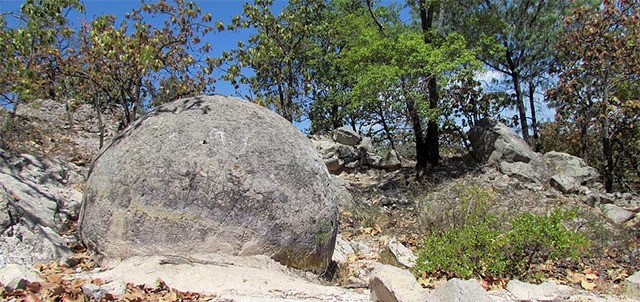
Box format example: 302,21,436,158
223,0,325,122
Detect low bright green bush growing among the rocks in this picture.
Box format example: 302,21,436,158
416,192,589,278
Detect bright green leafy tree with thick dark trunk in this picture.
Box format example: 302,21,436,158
344,2,477,172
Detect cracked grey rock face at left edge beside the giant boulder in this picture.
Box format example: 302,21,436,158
0,150,83,267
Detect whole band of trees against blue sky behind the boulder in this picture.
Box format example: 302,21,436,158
0,0,640,190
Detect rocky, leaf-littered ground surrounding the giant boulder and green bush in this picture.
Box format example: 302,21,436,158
0,101,640,301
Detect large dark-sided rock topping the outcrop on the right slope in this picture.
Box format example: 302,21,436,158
469,118,541,164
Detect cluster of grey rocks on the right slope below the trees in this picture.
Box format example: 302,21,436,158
469,118,640,224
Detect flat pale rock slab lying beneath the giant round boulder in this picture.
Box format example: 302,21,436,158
82,254,369,302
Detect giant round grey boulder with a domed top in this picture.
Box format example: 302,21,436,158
79,95,338,271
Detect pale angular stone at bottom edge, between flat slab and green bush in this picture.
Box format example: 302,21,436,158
369,264,430,302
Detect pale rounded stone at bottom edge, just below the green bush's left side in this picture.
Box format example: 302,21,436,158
431,278,492,302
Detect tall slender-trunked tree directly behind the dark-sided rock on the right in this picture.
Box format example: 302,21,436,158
457,0,568,145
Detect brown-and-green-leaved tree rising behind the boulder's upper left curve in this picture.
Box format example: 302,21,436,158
65,0,219,144
